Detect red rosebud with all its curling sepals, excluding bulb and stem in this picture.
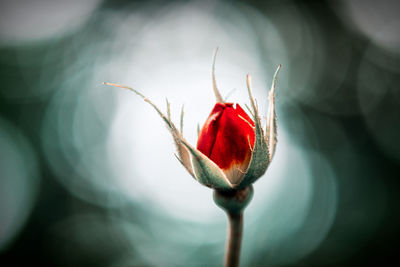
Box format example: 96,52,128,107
105,50,281,192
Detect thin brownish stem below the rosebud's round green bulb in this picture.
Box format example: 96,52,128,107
225,212,243,267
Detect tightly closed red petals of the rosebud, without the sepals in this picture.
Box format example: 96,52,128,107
197,102,255,184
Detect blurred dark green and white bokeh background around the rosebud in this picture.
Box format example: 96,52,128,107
0,0,400,267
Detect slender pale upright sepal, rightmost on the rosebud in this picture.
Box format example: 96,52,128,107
265,64,281,161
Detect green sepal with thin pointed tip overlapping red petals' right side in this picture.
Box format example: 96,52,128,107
237,75,270,191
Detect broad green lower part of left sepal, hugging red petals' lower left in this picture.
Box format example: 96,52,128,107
182,139,233,191
